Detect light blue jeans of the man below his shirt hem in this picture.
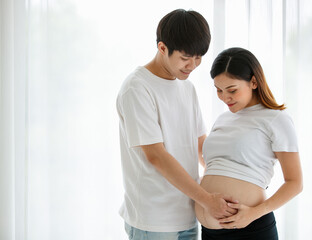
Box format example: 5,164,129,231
125,223,198,240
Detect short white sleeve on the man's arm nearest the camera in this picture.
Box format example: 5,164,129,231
119,88,163,147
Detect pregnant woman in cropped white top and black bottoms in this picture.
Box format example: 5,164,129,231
196,48,302,240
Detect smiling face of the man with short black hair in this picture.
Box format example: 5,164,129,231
163,51,202,80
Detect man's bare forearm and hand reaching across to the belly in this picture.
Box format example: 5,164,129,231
141,143,236,219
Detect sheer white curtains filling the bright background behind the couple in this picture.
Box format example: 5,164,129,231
0,0,312,240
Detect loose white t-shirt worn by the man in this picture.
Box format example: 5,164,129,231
117,67,206,232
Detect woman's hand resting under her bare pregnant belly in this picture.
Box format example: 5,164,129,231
219,203,261,229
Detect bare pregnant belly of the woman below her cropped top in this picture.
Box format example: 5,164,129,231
195,175,266,229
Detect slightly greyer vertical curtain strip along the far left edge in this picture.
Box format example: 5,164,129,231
0,0,27,240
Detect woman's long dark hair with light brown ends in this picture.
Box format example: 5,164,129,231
210,48,286,110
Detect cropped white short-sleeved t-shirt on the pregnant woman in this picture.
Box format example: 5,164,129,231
203,104,298,189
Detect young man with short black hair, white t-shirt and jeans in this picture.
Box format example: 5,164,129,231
117,9,234,240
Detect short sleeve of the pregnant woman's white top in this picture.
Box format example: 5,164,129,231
271,111,298,152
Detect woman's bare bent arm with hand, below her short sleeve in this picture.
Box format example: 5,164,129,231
220,152,303,229
